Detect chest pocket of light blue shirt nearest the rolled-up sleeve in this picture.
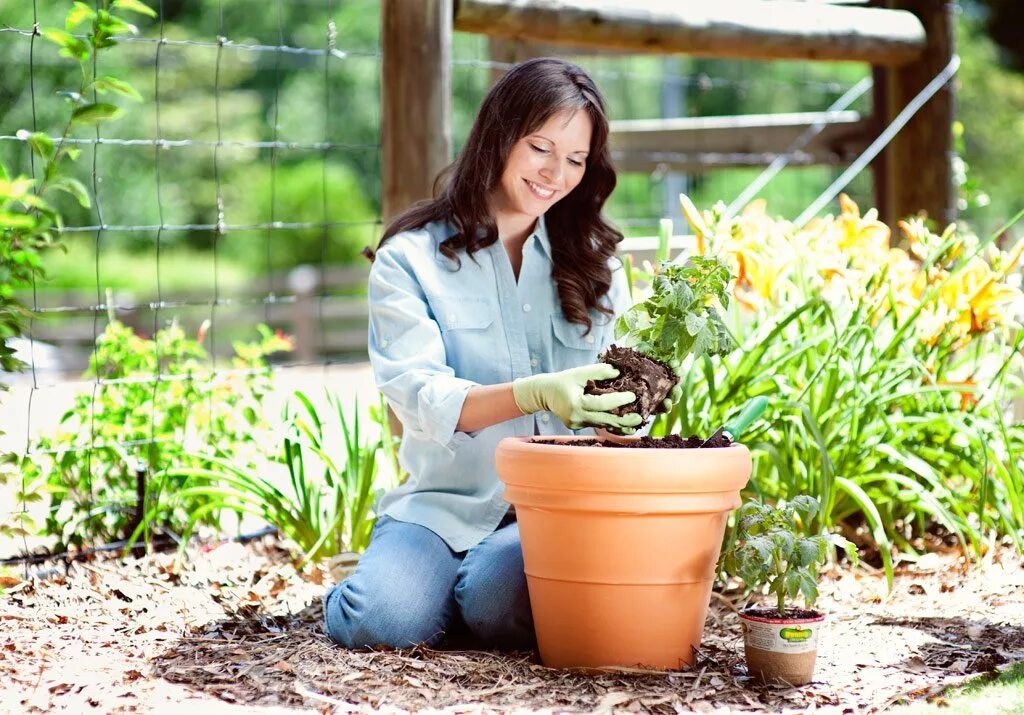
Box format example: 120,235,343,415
430,296,499,384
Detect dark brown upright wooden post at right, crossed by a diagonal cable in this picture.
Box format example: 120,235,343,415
872,0,956,230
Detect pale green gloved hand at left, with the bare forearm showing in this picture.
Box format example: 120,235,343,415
512,363,642,434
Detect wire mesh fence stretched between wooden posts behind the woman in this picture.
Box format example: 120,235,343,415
0,0,870,553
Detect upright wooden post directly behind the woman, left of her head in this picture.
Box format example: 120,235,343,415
381,0,452,222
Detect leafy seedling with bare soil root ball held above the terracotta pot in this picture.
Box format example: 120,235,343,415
586,256,734,422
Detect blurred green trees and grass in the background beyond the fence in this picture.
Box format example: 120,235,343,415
0,0,1024,323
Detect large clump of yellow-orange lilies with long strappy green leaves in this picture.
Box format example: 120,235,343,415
651,198,1024,580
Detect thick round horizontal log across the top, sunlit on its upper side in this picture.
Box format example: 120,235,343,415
455,0,926,66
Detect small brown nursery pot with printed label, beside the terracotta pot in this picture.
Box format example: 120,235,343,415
739,608,825,685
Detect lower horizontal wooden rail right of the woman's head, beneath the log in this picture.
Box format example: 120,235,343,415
609,112,873,171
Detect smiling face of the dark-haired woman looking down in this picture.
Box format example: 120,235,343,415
494,111,593,218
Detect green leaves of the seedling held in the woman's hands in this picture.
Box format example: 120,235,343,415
615,256,733,364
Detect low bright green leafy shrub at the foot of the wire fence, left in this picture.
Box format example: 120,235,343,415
8,319,291,550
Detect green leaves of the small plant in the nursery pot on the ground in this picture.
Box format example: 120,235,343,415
724,495,856,616
